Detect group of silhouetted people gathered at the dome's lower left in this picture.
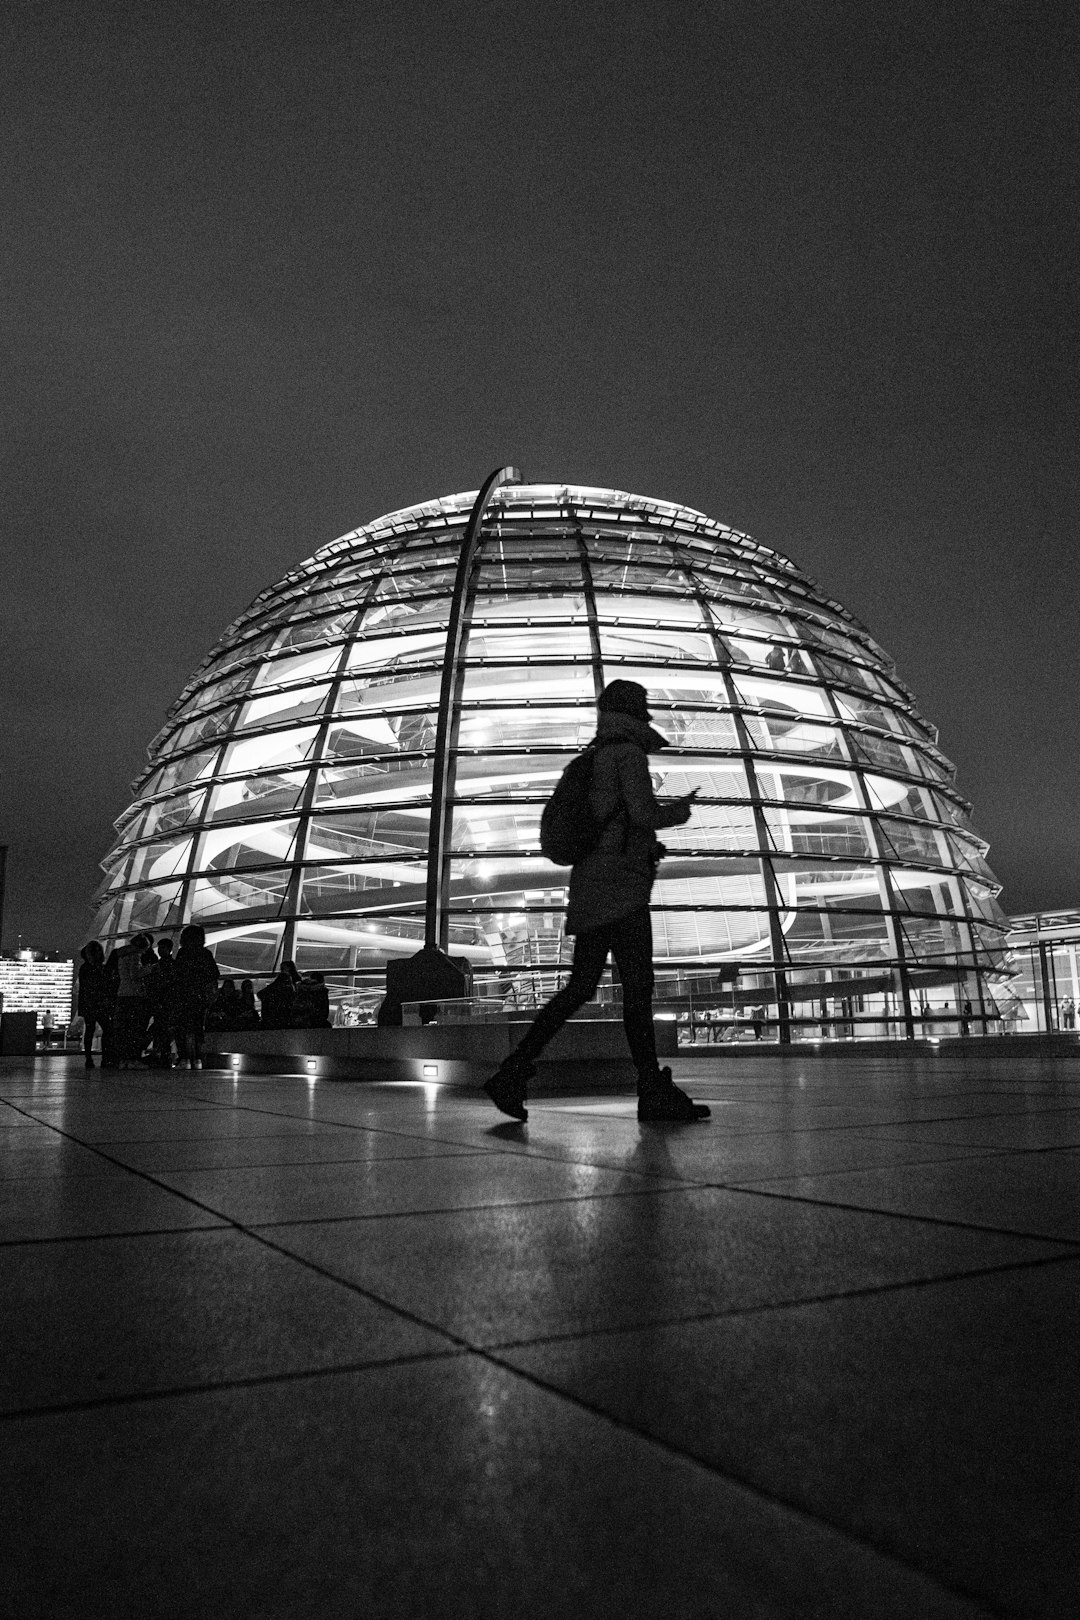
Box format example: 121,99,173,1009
78,923,330,1069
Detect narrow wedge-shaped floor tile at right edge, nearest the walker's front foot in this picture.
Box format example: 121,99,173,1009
746,1150,1080,1243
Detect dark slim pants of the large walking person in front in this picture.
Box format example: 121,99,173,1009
517,907,657,1084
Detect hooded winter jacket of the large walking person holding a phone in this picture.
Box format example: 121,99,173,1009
567,713,690,933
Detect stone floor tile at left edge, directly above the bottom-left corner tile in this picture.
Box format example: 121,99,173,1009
0,1228,450,1419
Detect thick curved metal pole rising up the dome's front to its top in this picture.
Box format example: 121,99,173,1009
424,467,521,951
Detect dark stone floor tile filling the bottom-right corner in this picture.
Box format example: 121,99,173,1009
507,1259,1080,1617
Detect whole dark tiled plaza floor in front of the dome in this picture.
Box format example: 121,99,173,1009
0,1053,1080,1620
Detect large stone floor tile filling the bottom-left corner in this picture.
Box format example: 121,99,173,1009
0,1356,980,1620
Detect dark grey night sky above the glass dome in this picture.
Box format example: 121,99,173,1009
0,0,1080,951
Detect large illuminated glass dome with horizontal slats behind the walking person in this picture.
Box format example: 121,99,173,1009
96,468,1004,1038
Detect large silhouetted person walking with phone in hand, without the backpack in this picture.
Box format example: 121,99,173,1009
484,680,709,1119
